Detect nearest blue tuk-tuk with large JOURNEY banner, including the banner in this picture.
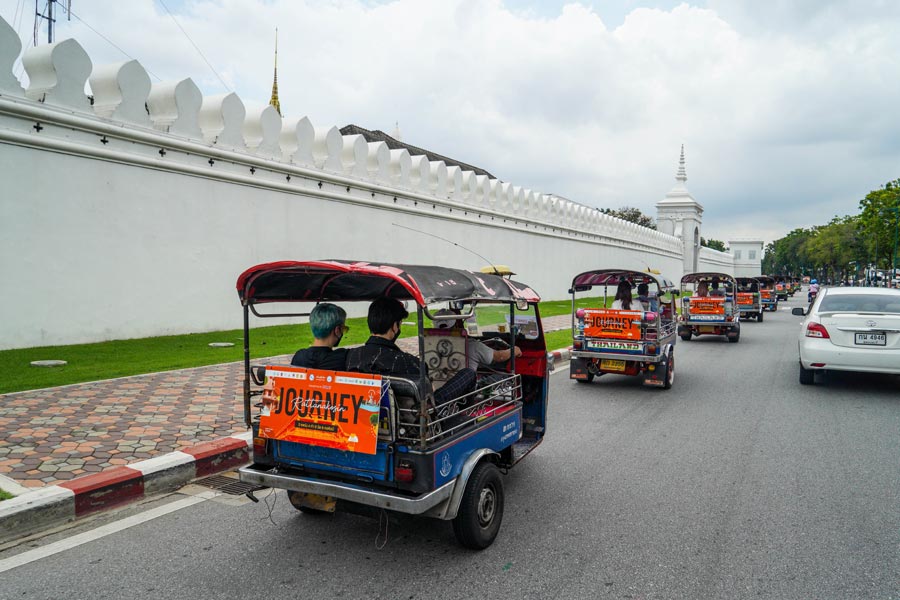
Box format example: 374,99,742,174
237,260,548,549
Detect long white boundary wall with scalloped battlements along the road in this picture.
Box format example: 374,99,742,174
0,19,682,348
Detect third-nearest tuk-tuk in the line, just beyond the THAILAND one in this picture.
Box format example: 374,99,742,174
678,272,741,343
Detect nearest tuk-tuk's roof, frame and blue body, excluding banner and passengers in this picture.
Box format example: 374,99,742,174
237,260,549,549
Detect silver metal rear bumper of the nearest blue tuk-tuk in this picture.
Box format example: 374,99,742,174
238,465,456,515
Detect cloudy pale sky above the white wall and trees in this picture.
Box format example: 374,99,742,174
0,0,900,240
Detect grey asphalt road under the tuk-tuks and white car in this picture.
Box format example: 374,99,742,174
0,296,900,600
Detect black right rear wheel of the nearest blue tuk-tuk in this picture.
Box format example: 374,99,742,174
453,460,504,550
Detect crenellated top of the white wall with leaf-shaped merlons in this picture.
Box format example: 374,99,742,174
0,19,682,255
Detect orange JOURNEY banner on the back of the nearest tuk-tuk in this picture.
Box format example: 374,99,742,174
259,366,387,454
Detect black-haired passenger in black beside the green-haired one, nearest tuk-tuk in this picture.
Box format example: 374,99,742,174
347,298,475,404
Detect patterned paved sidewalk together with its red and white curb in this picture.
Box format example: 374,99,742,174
0,315,571,541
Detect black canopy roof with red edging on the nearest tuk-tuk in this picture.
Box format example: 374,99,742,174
237,259,541,306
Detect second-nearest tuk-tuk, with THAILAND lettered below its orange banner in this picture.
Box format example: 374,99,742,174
569,269,676,389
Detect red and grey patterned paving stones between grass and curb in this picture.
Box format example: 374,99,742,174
0,315,571,488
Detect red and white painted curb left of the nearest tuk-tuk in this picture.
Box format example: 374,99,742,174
0,431,252,541
